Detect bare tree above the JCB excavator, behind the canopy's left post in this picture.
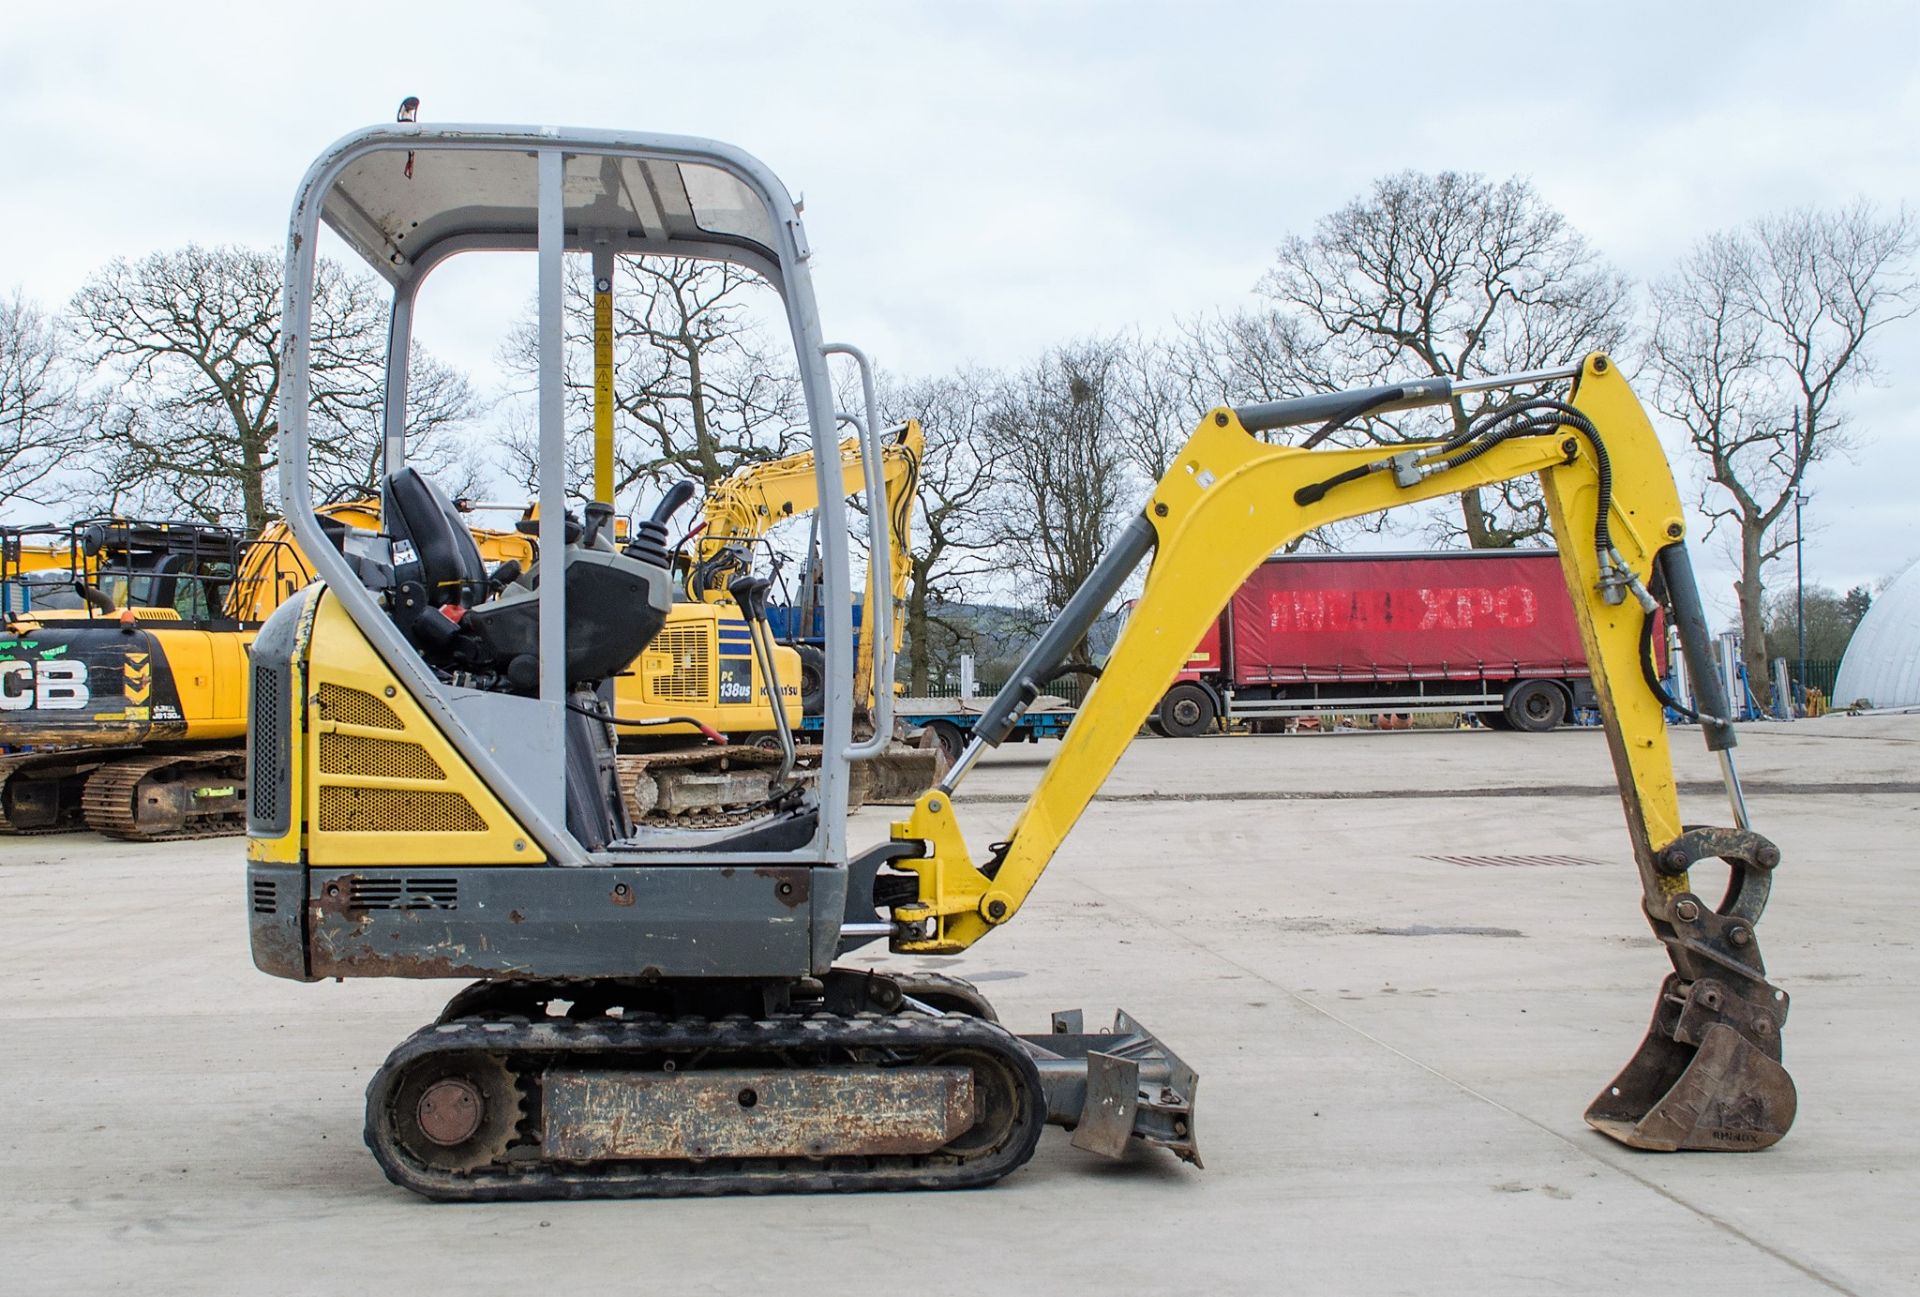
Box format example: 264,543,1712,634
73,244,472,533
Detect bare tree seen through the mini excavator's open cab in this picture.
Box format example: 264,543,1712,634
503,257,806,493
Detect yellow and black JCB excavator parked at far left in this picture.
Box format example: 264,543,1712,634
0,503,534,840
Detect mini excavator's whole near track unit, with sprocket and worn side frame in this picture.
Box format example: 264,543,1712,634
367,992,1046,1201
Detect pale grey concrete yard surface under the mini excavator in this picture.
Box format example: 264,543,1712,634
0,718,1920,1297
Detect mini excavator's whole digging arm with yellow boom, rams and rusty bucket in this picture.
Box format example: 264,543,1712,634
893,353,1793,1147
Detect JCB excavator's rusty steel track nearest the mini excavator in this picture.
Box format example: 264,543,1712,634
81,748,246,842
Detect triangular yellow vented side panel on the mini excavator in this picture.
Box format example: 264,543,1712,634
296,591,545,867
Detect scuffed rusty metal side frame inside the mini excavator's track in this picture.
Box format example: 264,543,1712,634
541,1067,975,1163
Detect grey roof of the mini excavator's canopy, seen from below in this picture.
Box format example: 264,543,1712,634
321,127,791,284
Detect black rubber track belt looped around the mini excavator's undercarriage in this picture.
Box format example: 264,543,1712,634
367,1013,1046,1201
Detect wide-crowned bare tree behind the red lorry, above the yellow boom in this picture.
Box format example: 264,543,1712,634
1244,171,1630,549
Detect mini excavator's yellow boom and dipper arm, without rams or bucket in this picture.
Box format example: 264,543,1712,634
893,355,1686,954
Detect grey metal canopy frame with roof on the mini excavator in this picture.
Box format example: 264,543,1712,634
280,123,883,863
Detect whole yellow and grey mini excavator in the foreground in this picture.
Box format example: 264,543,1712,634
246,125,1795,1199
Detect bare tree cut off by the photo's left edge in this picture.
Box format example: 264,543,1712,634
0,288,81,507
